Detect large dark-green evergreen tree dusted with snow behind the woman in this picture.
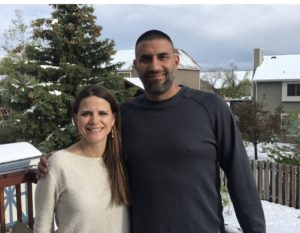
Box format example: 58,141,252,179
0,4,132,152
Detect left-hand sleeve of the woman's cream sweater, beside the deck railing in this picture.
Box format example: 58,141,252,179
34,168,58,233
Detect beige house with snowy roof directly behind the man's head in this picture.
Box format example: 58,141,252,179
112,49,200,89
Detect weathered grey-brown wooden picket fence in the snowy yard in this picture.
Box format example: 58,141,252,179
221,160,300,209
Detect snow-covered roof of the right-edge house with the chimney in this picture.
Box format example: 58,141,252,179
253,54,300,82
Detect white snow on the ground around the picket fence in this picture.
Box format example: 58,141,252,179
223,144,300,233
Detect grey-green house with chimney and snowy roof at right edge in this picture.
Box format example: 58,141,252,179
253,49,300,113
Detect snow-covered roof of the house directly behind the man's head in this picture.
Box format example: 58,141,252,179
112,49,200,71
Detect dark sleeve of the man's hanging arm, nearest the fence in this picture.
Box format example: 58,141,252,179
214,94,266,233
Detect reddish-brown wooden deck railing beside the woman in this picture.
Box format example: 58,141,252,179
0,169,37,233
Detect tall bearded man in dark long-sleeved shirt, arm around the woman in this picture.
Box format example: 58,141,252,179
39,30,266,233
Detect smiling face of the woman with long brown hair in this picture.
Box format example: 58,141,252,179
74,96,115,145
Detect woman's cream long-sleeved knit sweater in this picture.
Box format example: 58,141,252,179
34,150,129,233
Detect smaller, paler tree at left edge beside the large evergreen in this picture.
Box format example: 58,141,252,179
0,10,34,143
